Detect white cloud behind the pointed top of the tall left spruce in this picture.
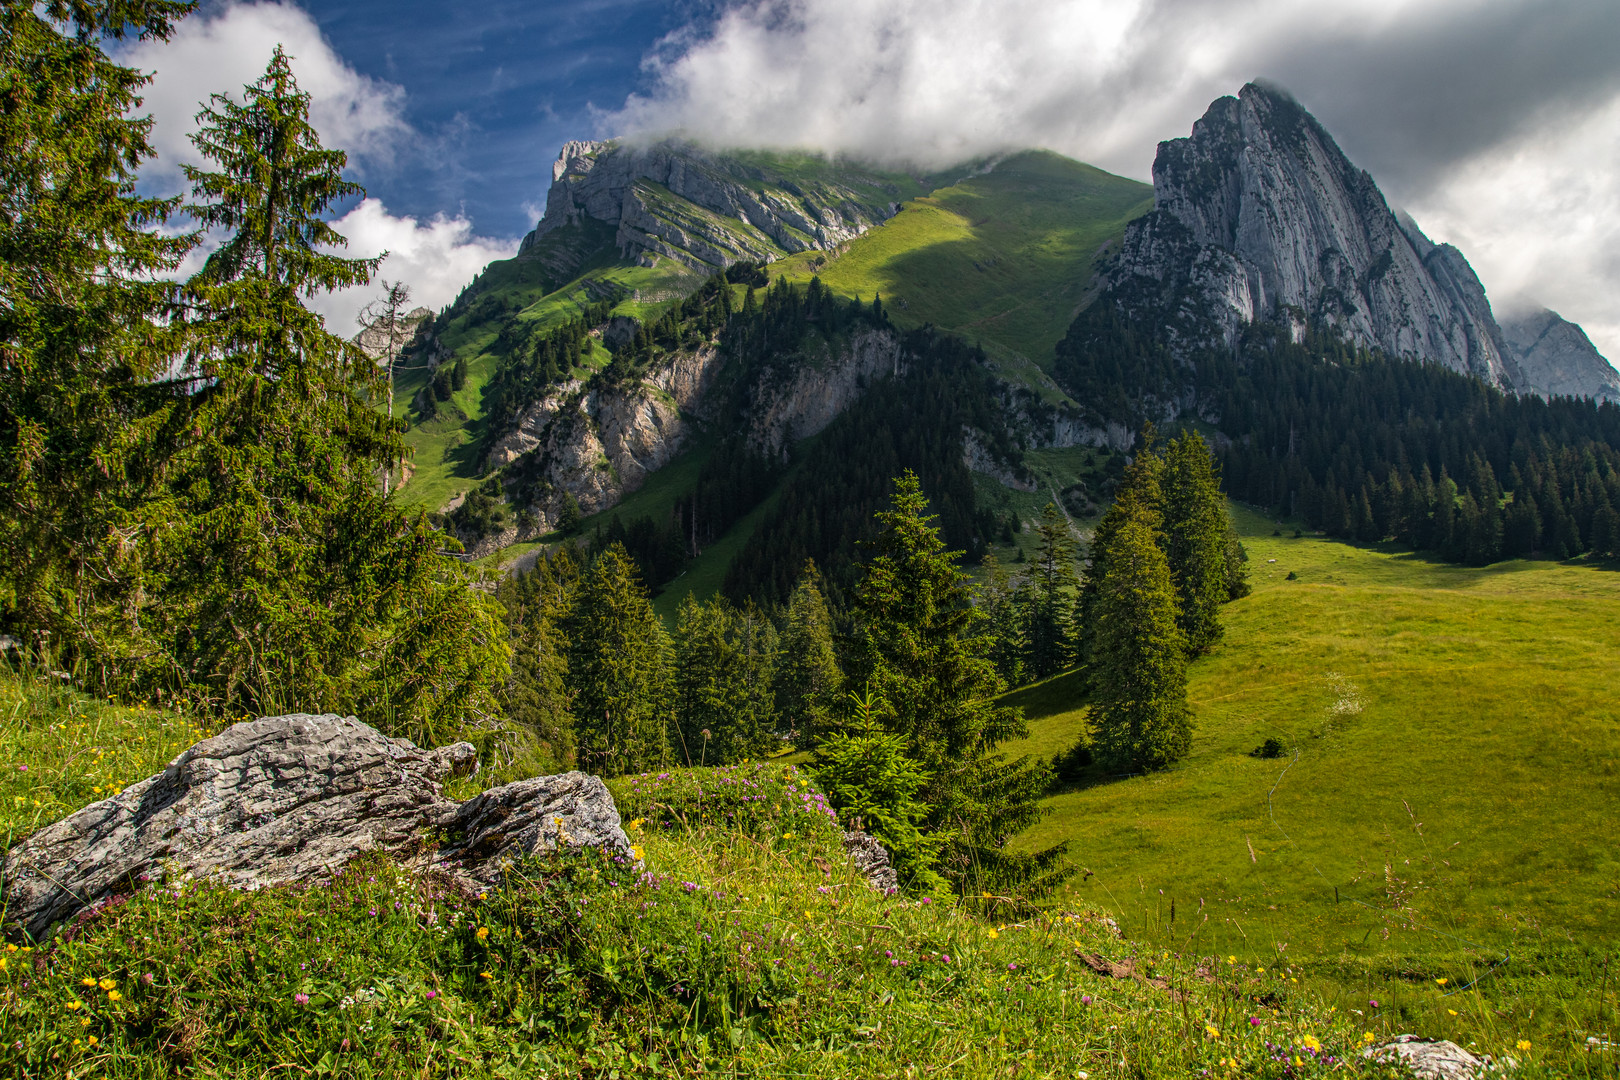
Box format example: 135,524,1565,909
118,3,411,185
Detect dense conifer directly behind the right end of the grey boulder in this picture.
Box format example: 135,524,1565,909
562,544,671,776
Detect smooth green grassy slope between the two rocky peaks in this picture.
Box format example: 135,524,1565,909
771,151,1153,369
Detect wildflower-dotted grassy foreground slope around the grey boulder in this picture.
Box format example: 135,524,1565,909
0,677,1503,1077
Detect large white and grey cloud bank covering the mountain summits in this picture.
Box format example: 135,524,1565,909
603,0,1620,359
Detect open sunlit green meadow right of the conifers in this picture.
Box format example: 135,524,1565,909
1011,512,1620,1062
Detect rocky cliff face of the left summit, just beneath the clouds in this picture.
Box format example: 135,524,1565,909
520,142,897,272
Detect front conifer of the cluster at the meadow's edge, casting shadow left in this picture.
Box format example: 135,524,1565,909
1092,507,1192,772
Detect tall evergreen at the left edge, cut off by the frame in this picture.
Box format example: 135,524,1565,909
0,0,196,672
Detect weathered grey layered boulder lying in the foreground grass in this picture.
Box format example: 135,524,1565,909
5,714,630,939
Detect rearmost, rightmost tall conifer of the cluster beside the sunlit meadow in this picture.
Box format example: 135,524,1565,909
1162,432,1231,656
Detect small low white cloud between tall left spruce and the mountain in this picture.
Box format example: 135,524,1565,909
308,199,518,337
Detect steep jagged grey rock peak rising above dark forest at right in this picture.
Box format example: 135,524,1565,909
1108,84,1533,390
